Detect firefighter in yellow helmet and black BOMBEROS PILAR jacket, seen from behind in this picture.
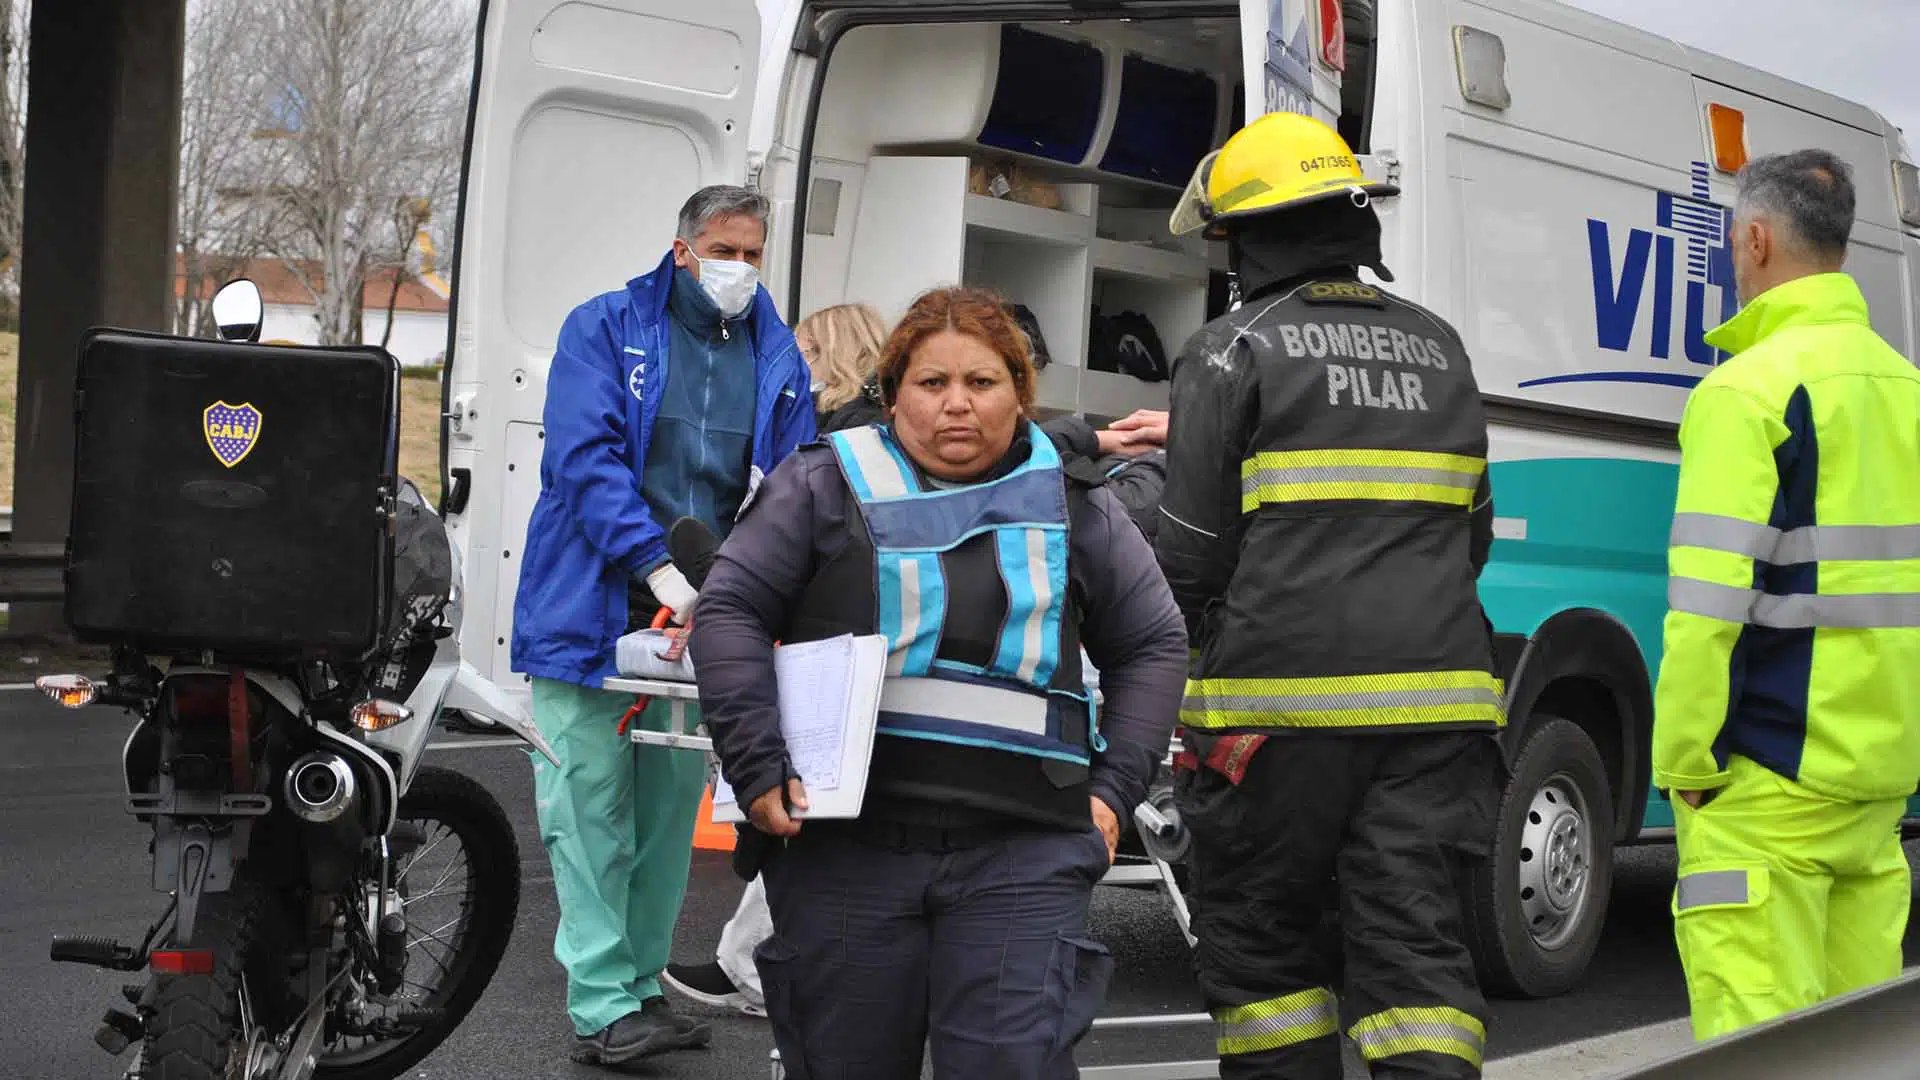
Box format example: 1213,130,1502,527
1156,113,1503,1080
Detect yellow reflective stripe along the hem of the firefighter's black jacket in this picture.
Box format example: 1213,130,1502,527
1181,671,1505,728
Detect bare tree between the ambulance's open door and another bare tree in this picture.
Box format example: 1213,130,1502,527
253,0,472,344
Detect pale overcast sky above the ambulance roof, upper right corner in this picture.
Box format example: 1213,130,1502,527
1567,0,1920,148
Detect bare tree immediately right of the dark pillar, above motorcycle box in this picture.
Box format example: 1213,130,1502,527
173,0,290,334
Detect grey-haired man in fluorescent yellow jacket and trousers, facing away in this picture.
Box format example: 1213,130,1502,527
1653,150,1920,1040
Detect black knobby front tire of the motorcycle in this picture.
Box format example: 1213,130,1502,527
315,765,520,1080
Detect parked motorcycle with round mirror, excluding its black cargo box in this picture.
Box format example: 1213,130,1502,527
36,279,557,1080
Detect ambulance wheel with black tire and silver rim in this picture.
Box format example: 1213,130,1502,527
1465,713,1613,997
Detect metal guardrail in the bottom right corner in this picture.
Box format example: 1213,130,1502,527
1615,970,1920,1080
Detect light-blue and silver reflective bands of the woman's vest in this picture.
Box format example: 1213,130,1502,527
828,423,1100,765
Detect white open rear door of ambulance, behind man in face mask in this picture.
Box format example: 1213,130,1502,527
445,0,760,688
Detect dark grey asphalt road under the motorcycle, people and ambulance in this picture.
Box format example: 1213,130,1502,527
0,692,1920,1080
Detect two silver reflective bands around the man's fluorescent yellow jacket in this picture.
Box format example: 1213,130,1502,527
1667,513,1920,630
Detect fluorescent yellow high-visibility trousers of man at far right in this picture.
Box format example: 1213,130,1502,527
1672,755,1912,1040
